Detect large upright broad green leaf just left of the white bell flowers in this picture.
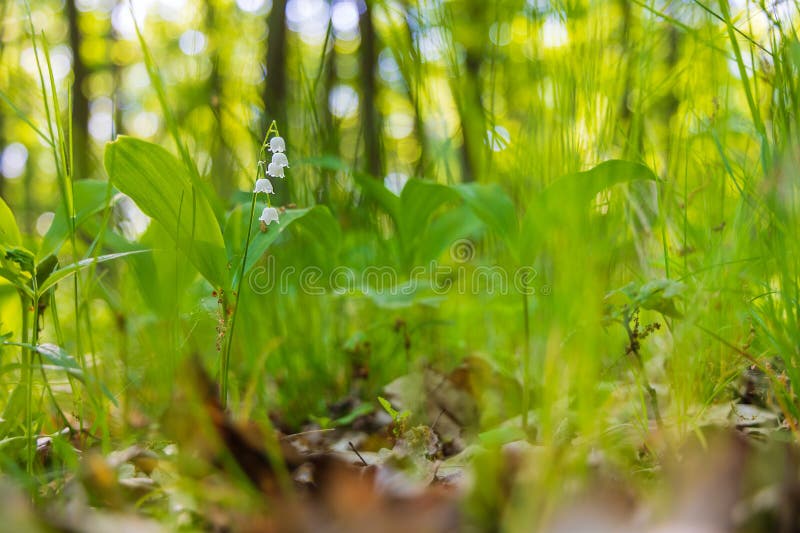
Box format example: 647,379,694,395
105,136,228,287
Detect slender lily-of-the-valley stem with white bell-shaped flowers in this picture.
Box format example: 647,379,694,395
220,120,289,407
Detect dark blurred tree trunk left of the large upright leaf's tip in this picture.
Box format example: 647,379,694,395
66,0,91,179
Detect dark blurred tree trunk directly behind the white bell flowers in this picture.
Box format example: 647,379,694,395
262,0,290,203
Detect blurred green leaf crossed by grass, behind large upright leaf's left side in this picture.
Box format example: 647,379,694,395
39,180,115,257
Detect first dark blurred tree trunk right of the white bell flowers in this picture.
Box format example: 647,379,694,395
358,2,384,179
